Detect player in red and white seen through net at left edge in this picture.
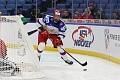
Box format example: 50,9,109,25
0,39,21,76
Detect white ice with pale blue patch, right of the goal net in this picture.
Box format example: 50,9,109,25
41,51,120,80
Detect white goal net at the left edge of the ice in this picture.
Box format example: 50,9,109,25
0,16,44,80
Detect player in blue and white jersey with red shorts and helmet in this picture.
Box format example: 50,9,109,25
37,10,73,65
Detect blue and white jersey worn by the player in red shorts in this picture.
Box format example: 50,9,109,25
37,15,67,38
